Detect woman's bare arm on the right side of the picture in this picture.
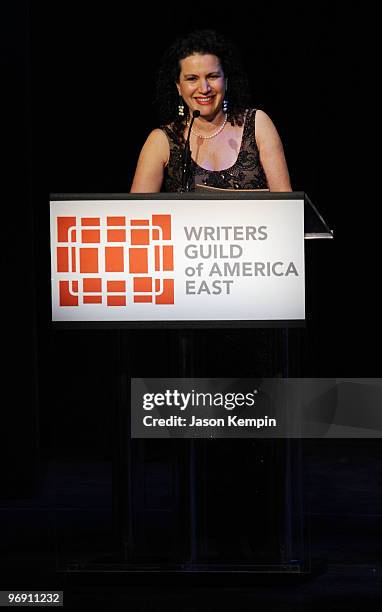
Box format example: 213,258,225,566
255,110,292,191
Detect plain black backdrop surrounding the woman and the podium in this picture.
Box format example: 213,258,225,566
0,0,382,605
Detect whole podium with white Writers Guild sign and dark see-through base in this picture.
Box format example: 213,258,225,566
51,192,333,576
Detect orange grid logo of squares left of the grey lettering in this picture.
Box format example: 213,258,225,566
56,215,174,307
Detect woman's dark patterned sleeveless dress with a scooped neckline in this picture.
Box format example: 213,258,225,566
161,108,268,193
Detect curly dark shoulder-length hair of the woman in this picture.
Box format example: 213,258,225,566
155,30,250,141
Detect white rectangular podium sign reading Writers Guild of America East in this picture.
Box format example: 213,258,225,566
51,196,305,322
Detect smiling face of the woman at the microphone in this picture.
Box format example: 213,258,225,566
176,53,227,119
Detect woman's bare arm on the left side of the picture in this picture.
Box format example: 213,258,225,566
130,129,170,193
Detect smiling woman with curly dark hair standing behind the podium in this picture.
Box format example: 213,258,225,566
131,30,291,193
